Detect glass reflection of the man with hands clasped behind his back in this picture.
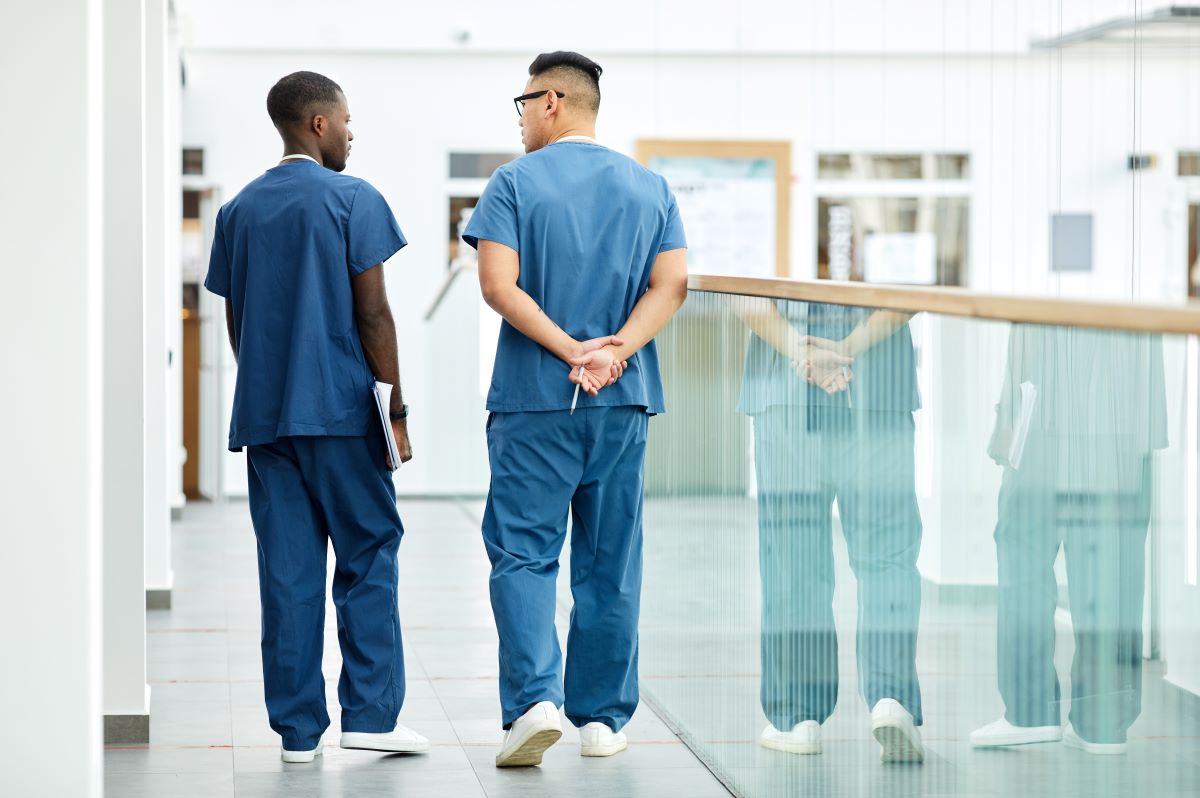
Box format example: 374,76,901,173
738,300,924,762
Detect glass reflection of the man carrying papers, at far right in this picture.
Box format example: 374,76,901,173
971,325,1166,754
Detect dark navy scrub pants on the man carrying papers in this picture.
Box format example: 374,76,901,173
247,434,404,751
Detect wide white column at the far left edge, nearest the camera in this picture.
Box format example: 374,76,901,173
0,0,103,798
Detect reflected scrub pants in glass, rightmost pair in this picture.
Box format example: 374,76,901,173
995,434,1151,743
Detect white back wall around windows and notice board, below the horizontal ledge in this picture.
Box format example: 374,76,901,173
184,43,1200,493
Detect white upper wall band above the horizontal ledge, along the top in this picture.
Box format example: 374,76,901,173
179,0,1147,55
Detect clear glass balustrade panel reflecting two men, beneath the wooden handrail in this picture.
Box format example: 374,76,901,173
641,290,1200,797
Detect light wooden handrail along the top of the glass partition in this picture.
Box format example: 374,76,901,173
688,275,1200,335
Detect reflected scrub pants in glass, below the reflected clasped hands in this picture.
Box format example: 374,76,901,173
754,406,923,731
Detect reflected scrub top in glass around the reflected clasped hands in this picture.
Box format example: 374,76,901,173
738,300,920,415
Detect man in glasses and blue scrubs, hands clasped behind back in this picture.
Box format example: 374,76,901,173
463,53,688,767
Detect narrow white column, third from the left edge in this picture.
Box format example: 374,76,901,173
143,0,179,610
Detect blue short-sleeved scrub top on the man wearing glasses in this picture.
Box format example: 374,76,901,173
462,142,688,413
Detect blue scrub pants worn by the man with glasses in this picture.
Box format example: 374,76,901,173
484,407,649,731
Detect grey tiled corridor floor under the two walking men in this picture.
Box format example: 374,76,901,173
104,500,730,798
